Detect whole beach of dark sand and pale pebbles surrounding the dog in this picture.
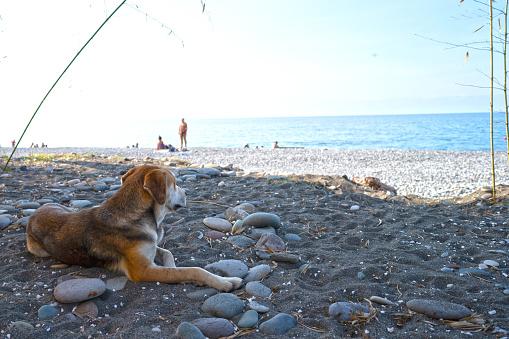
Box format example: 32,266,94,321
0,148,509,339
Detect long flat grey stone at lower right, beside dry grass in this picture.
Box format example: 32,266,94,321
406,299,472,320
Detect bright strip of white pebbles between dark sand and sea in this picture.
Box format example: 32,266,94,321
0,147,509,199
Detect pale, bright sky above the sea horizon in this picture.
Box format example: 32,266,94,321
0,0,504,144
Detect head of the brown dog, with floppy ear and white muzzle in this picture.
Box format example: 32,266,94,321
122,165,186,212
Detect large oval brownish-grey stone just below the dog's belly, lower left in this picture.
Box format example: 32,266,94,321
53,278,106,304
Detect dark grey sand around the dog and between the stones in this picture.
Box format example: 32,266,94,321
0,158,509,338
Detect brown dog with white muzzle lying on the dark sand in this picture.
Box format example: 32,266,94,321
26,165,242,292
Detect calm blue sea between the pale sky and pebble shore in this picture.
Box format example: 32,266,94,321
11,113,507,151
